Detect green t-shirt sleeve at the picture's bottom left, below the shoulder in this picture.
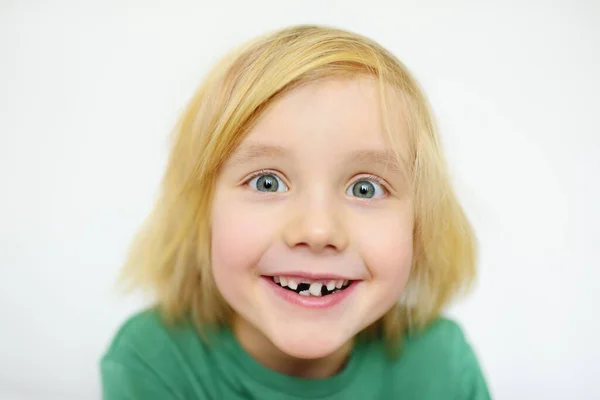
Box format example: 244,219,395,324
100,359,179,400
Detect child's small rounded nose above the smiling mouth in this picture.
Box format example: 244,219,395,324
283,195,348,253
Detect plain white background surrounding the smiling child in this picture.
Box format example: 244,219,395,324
0,0,600,400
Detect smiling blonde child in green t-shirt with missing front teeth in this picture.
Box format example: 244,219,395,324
101,26,490,400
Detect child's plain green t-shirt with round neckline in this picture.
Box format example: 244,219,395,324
100,310,490,400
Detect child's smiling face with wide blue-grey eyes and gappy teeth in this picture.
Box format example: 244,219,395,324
212,77,413,358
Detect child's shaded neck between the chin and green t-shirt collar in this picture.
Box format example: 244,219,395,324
233,318,353,379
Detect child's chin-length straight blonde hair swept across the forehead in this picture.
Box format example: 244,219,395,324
123,26,476,340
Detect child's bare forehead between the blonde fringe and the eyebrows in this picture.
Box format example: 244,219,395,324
241,76,407,157
